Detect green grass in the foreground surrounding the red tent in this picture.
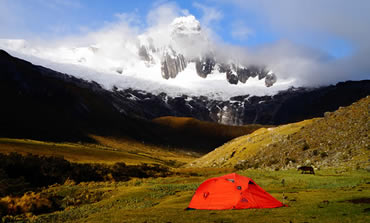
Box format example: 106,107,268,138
26,169,370,222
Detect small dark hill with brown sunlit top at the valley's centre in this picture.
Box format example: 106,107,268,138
153,116,266,153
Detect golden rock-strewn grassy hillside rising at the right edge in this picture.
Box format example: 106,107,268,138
188,96,370,169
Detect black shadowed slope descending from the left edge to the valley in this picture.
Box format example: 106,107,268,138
0,50,260,152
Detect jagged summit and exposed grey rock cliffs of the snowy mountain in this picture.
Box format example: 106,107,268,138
138,16,277,87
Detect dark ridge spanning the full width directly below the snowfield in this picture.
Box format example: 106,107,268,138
0,50,370,150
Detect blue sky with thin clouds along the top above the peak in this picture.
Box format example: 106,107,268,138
0,0,370,58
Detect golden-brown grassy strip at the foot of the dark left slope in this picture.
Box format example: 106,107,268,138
0,135,194,166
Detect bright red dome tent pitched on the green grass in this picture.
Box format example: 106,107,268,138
188,173,284,210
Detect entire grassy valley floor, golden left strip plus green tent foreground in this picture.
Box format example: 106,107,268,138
0,136,370,223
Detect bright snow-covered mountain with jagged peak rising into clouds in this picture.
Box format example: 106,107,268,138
0,15,286,99
